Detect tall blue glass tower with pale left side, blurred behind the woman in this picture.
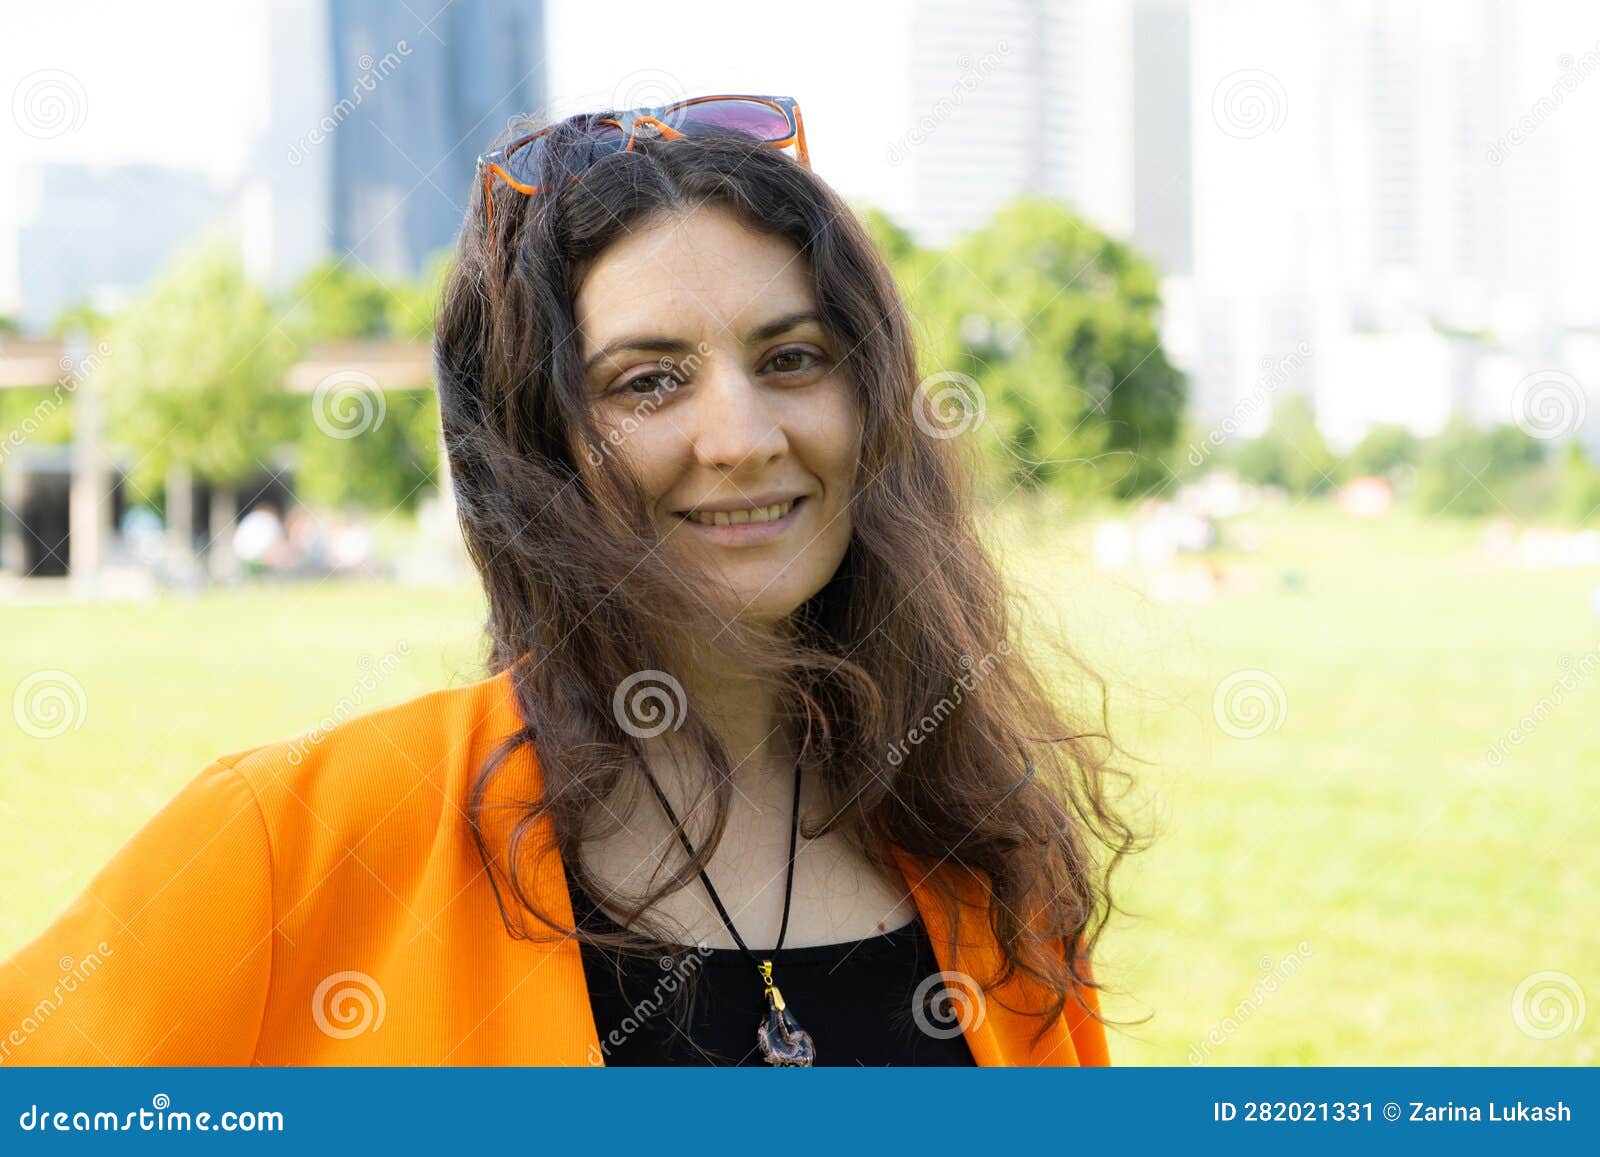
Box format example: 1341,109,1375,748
240,0,547,286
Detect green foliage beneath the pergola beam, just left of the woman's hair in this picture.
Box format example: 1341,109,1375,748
294,387,438,514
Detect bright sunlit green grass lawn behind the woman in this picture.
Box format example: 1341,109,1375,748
0,507,1600,1064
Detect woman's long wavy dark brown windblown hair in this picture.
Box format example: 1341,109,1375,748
435,111,1141,1035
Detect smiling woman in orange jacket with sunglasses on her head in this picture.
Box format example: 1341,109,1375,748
0,98,1152,1066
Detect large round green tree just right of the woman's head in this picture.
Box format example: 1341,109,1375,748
864,195,1187,498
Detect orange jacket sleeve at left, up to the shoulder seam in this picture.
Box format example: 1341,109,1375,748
0,760,272,1066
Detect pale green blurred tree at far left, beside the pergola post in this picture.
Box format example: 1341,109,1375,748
99,242,294,490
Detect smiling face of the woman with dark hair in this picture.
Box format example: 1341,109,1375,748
574,206,861,619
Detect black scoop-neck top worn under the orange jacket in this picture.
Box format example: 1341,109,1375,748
566,874,976,1066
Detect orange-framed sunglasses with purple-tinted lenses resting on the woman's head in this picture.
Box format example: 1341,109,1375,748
478,94,811,233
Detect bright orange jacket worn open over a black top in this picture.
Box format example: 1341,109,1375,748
0,672,1110,1066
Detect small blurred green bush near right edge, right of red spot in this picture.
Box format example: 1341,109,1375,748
1416,418,1547,518
